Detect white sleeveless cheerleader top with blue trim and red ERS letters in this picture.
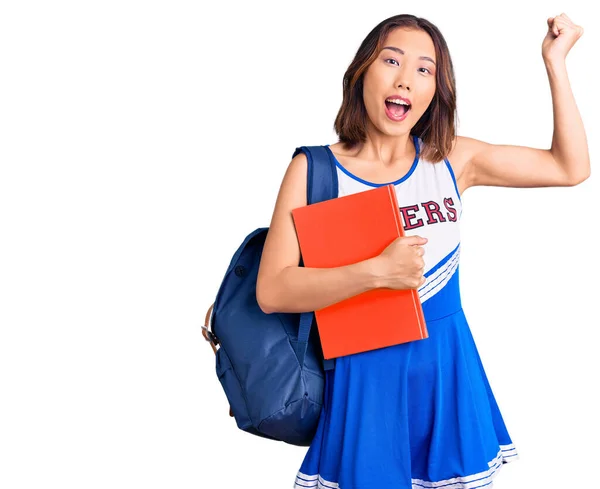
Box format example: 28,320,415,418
325,136,462,302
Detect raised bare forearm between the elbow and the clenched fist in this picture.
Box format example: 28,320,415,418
545,61,590,182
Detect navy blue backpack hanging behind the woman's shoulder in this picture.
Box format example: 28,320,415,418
202,146,338,446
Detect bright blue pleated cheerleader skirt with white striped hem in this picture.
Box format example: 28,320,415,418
294,298,518,489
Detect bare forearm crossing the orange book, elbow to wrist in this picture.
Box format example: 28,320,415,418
261,257,383,313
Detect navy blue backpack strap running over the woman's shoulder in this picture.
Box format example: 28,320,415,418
292,146,338,370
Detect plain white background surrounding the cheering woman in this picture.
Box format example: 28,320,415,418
0,0,600,489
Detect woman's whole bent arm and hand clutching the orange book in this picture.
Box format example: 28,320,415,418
256,153,424,314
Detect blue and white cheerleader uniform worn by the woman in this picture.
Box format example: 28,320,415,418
294,136,518,489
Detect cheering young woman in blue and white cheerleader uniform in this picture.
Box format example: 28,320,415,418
257,14,590,489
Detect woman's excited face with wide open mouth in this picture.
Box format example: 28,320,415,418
363,27,437,136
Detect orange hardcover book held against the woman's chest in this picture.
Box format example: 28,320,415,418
292,184,428,359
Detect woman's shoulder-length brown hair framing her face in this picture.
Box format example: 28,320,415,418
334,14,457,162
